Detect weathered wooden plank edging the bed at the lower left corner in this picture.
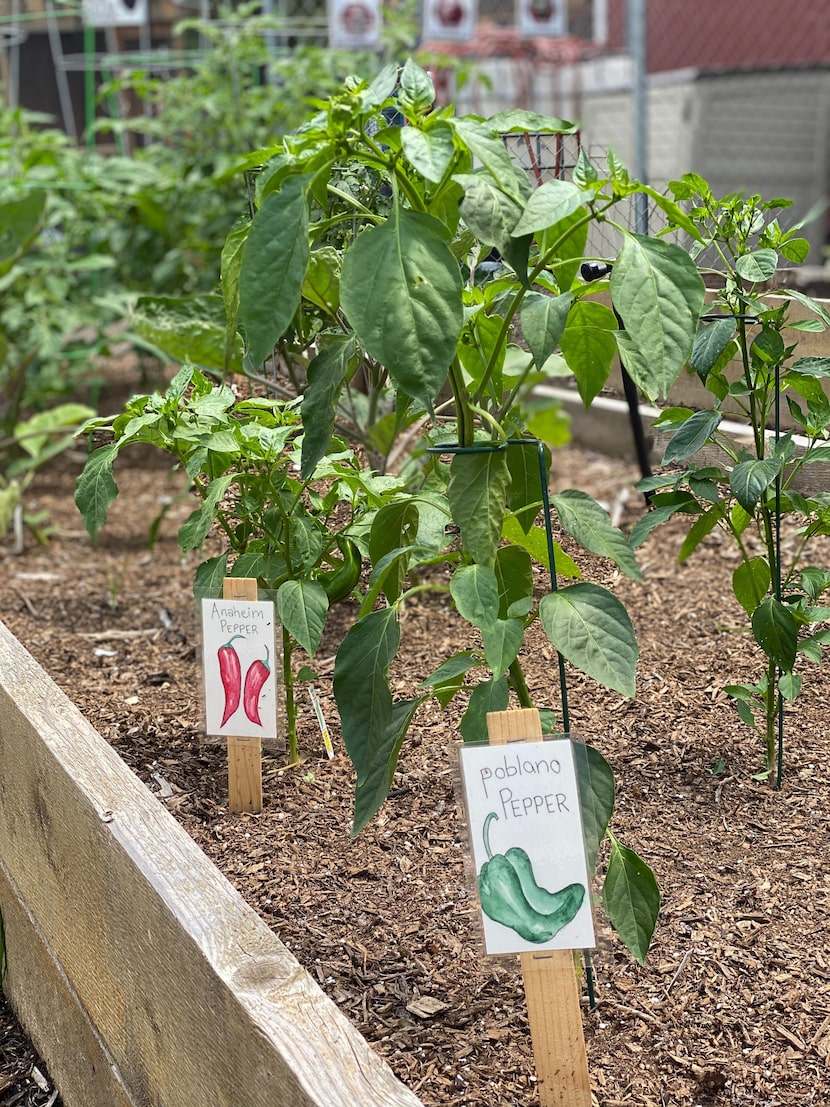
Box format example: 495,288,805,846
0,623,421,1107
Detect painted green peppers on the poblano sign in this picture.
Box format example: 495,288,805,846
478,811,585,944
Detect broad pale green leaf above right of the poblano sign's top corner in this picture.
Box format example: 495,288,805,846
539,581,640,696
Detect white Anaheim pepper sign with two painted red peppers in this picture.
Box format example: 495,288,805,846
201,599,277,738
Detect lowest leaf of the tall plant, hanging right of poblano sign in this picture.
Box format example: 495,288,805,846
602,837,660,965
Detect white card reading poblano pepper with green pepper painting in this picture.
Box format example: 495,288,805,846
460,738,595,954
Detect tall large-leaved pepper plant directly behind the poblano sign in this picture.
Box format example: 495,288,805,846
79,62,704,960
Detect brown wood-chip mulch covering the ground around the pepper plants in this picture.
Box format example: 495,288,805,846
0,369,830,1107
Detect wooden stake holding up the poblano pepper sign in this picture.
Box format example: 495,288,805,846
487,707,591,1107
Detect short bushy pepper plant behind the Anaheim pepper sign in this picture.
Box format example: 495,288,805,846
75,364,402,764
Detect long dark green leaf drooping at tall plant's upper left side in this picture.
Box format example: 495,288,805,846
239,175,310,368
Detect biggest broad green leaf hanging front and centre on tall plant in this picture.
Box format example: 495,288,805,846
341,206,464,408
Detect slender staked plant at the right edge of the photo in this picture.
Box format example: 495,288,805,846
631,174,830,784
